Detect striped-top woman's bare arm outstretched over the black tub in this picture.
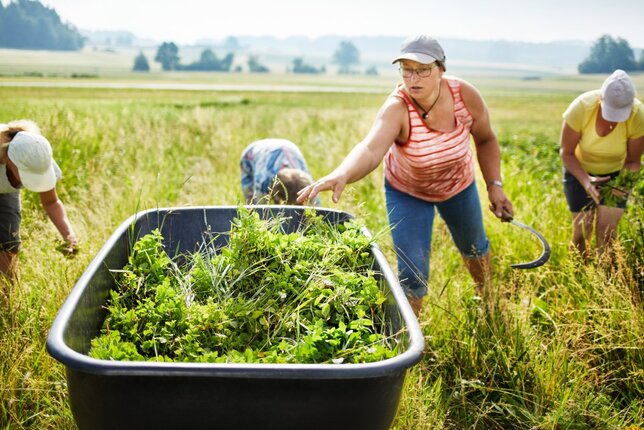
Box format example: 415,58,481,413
297,97,407,203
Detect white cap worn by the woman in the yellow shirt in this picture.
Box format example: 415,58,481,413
601,69,635,122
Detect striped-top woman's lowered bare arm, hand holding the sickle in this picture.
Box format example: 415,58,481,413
461,81,514,220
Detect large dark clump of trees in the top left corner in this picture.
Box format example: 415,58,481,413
0,0,85,51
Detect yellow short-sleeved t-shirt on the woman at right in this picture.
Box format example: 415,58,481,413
563,90,644,175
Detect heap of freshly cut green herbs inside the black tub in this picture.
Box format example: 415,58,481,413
90,207,398,364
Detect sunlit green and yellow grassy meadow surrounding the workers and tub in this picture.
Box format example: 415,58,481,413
0,69,644,430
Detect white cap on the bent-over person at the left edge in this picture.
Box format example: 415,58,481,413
7,131,60,193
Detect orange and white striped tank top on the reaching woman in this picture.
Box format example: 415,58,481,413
385,79,474,202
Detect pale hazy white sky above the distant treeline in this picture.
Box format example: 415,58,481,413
39,0,644,48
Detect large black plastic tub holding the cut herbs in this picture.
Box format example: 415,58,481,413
47,206,424,430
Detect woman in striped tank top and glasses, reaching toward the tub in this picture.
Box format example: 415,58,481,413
298,35,513,315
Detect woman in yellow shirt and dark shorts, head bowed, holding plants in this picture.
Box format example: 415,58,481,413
560,70,644,257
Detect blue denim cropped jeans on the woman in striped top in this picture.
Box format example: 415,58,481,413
385,180,490,298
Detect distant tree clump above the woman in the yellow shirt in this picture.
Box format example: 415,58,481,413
577,34,637,73
